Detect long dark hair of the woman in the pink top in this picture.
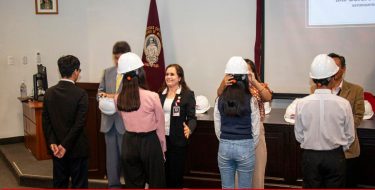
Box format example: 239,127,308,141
117,67,148,112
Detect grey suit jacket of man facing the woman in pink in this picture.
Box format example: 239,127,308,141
98,67,125,134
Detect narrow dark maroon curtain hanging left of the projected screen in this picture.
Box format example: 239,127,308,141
254,0,264,79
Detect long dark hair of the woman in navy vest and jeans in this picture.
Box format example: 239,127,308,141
219,75,251,117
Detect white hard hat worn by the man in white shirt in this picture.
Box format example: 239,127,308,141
310,54,339,79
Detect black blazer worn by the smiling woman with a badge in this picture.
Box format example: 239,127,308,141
159,87,197,148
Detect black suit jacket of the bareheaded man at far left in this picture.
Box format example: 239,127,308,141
42,80,89,158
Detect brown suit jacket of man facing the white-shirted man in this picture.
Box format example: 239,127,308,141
339,80,365,158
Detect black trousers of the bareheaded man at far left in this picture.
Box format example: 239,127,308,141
53,156,88,188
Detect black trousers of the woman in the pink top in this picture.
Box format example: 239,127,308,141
121,131,165,188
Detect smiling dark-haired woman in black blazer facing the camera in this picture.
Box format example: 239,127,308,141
159,64,197,188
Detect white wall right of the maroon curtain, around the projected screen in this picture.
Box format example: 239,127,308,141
264,0,375,93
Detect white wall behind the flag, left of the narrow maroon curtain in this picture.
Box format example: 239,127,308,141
0,0,255,138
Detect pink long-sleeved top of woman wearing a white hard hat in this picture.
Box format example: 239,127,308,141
115,88,167,152
